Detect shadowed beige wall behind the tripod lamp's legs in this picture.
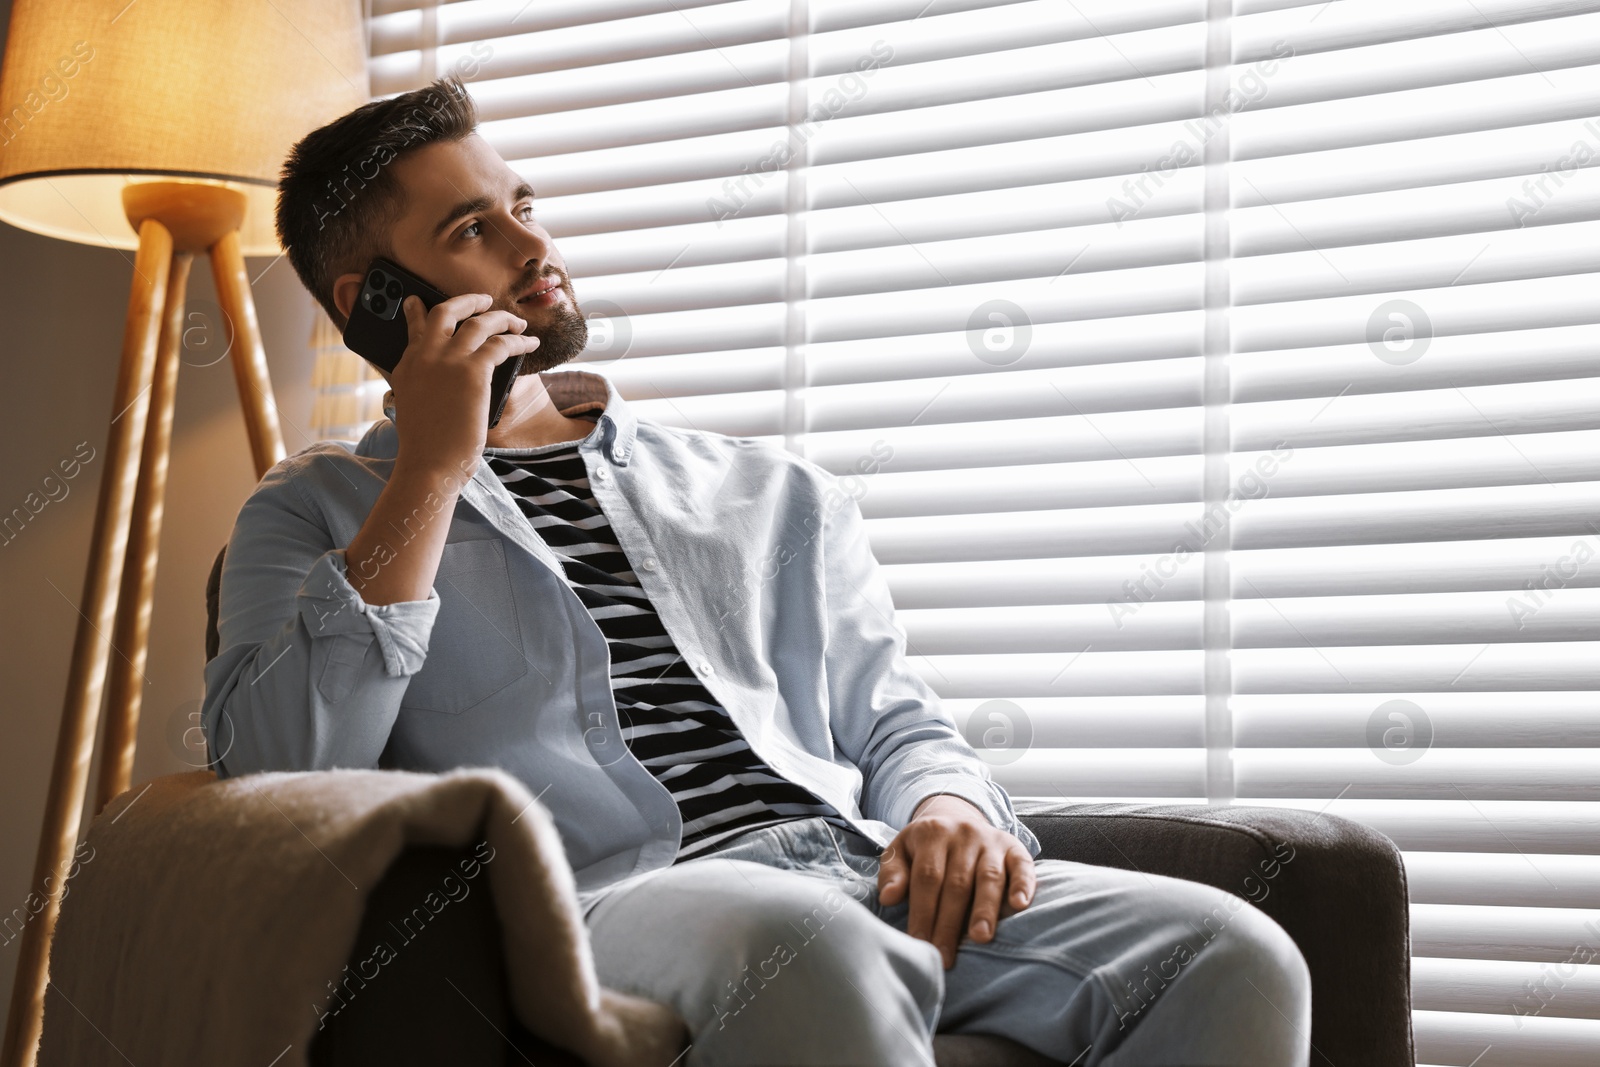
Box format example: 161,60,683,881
0,185,321,1036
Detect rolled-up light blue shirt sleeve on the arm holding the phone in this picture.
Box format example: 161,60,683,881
200,451,440,777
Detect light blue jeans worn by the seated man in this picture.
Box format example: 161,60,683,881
579,817,1310,1067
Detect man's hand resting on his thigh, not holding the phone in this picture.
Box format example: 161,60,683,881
878,793,1034,971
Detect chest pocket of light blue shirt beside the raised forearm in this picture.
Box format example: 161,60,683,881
400,539,528,715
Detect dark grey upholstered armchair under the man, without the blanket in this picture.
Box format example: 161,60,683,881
206,552,1416,1067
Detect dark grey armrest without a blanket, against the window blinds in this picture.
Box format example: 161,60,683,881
1016,801,1416,1067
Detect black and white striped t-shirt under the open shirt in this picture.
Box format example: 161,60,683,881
483,428,850,862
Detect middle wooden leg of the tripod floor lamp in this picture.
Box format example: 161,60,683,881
91,253,194,814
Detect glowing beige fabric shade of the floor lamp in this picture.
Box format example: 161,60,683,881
0,0,368,256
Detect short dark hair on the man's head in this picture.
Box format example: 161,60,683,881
277,74,478,330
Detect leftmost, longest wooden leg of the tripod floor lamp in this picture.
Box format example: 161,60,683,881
0,219,173,1067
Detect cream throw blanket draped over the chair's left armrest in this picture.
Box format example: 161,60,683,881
38,768,688,1067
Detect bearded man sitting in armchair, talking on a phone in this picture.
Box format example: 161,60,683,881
203,80,1310,1067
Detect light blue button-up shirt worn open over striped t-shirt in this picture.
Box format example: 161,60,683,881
202,370,1040,891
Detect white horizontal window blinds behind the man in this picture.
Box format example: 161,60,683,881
360,0,1600,1067
